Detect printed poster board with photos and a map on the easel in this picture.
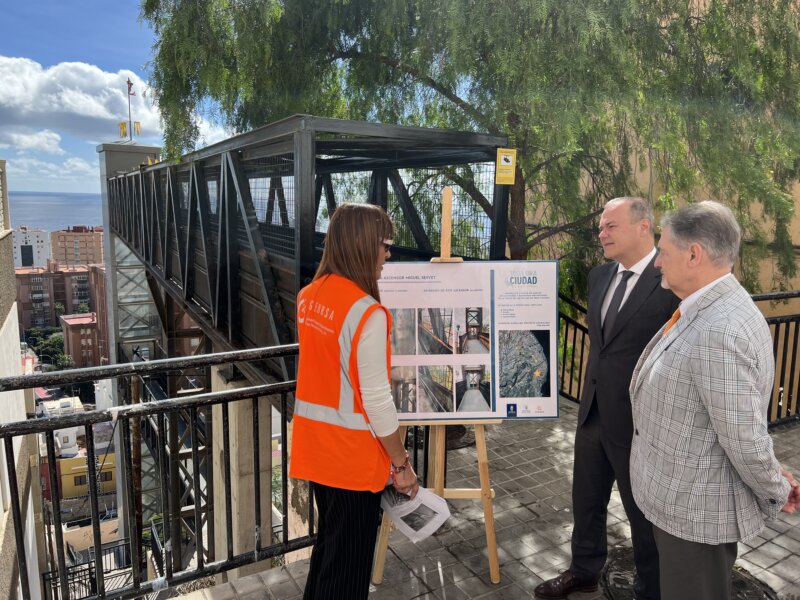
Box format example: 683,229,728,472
378,261,558,422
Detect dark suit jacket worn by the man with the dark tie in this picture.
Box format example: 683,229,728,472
578,259,680,447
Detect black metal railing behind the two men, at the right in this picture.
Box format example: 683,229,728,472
558,291,800,427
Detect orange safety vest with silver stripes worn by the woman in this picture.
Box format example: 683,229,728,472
289,275,392,492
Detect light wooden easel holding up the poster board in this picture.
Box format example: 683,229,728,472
372,187,502,585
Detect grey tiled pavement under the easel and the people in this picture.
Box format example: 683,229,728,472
183,401,800,600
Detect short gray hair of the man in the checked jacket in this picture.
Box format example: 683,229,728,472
661,200,742,267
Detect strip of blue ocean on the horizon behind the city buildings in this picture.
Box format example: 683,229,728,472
8,190,103,231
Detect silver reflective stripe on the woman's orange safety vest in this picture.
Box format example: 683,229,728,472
294,296,378,431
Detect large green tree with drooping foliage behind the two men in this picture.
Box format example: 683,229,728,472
142,0,800,292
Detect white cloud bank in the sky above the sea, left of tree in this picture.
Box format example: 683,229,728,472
0,55,231,190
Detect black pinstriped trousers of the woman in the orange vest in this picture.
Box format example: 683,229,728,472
303,483,381,600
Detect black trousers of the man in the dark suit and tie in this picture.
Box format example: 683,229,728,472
570,401,661,600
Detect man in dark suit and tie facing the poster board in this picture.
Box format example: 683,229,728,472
534,198,679,600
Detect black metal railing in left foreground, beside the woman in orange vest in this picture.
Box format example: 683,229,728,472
0,344,315,599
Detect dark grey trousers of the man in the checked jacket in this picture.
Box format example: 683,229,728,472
653,526,738,600
